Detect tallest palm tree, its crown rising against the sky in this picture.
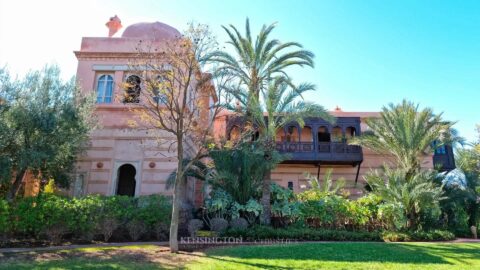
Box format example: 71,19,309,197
209,18,320,224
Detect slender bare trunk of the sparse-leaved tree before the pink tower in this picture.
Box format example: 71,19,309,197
170,140,184,253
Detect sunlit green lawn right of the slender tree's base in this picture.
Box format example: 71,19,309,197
193,242,480,270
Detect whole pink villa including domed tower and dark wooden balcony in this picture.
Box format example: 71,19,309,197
65,16,455,205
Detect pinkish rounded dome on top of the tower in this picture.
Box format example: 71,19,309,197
122,22,181,40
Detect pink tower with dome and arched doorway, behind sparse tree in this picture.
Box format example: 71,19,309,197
73,16,186,196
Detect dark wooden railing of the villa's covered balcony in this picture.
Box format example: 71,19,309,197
276,142,363,163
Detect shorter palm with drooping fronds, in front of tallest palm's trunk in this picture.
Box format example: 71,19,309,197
230,77,334,224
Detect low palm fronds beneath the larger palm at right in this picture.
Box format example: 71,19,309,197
365,167,444,229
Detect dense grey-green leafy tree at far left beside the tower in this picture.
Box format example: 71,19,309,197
0,66,95,200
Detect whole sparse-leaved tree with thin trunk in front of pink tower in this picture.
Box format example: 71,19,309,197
126,24,229,252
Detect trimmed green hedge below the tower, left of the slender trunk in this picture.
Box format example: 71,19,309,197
0,194,171,243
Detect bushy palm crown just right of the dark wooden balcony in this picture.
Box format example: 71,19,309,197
351,100,456,179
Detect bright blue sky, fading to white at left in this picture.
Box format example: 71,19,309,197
0,0,480,140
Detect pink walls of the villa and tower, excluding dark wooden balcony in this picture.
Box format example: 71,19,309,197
72,17,433,200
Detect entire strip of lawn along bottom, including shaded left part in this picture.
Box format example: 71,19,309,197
0,243,480,270
